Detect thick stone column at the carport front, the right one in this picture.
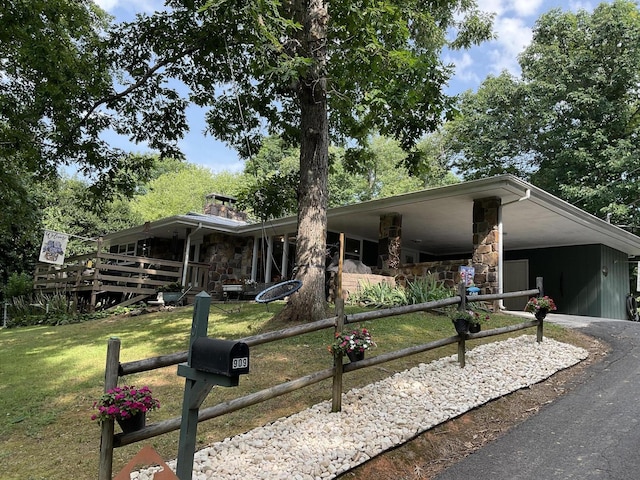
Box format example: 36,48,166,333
472,197,501,294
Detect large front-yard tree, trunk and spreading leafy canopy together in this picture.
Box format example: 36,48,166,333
0,0,491,319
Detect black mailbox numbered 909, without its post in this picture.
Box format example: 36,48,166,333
191,337,249,377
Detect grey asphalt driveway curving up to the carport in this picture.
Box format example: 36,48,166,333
436,315,640,480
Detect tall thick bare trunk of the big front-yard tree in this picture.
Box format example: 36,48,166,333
280,0,329,321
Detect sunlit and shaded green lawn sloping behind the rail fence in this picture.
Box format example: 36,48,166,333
0,302,567,480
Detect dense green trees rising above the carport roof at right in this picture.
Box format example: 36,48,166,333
448,0,640,225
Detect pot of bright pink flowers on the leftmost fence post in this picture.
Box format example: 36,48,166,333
91,386,160,433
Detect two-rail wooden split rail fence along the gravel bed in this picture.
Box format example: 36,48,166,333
98,278,543,480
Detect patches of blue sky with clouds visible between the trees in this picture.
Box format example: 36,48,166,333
94,0,601,172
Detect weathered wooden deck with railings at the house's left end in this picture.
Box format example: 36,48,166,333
34,252,208,310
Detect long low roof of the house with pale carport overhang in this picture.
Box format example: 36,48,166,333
105,175,640,256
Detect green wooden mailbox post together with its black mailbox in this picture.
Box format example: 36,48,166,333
176,292,249,480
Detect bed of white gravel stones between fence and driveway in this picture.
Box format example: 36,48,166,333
131,335,588,480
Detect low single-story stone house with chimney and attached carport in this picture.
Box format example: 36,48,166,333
33,175,640,319
